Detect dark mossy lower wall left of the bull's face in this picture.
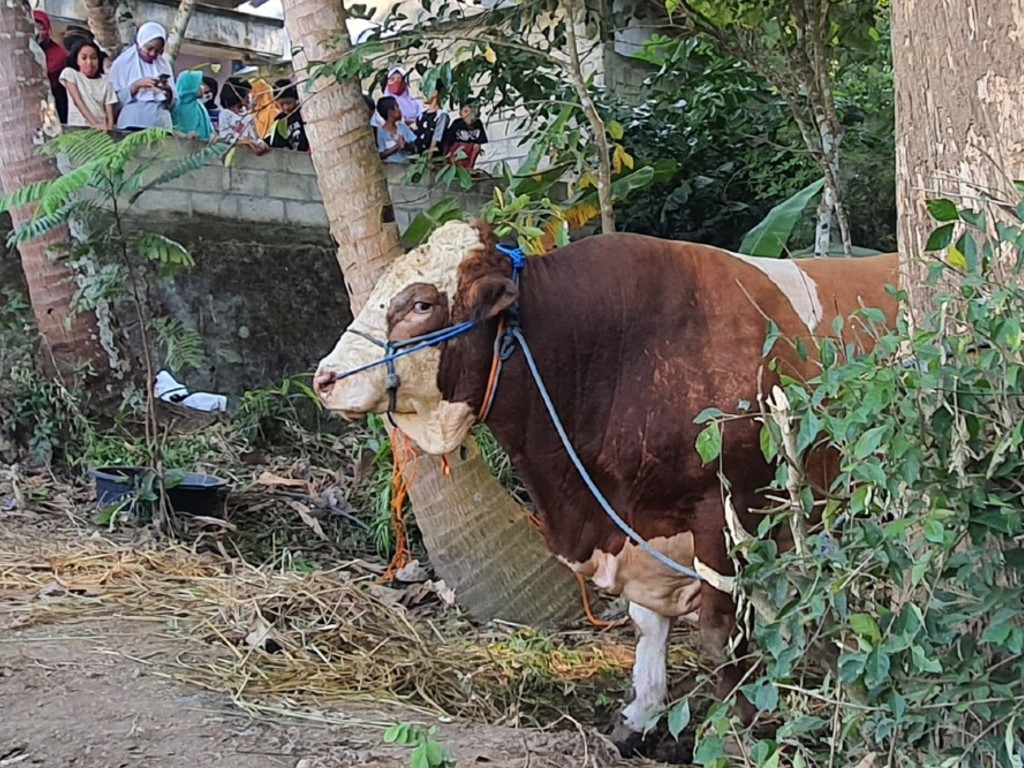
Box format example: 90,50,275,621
138,218,351,403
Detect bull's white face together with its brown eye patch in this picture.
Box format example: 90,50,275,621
314,221,514,454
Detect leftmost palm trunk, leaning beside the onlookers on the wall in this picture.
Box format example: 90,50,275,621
0,0,110,382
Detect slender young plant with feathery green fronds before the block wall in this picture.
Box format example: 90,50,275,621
0,128,229,514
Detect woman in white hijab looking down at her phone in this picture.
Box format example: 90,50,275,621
110,22,174,131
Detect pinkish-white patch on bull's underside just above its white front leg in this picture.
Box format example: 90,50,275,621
559,532,700,618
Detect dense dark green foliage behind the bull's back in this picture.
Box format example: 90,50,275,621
615,37,896,251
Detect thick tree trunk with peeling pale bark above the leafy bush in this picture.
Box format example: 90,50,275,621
892,0,1024,322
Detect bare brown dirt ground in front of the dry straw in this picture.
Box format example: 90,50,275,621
0,513,655,768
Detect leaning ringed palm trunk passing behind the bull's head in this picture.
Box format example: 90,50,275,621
284,0,581,625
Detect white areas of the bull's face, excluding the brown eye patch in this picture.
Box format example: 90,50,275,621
314,221,483,454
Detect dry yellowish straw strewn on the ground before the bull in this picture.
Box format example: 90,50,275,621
0,537,694,725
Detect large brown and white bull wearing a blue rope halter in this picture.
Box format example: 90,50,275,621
316,222,897,753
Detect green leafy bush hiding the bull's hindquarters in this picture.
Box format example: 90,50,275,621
679,202,1024,768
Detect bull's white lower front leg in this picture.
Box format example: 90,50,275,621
612,602,672,755
